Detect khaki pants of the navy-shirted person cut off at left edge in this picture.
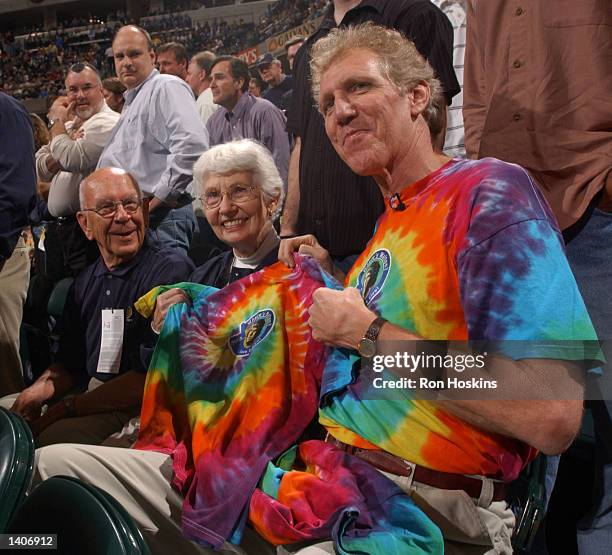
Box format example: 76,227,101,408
0,237,30,397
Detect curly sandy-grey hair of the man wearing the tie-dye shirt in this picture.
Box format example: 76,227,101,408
310,23,442,119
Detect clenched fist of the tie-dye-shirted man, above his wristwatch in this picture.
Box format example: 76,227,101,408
308,287,376,349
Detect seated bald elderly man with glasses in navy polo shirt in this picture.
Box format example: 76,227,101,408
0,168,193,445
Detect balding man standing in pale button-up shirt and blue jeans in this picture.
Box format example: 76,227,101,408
98,25,208,251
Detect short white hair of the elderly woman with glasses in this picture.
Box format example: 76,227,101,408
193,139,285,219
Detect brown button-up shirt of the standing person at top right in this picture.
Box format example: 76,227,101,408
463,0,612,228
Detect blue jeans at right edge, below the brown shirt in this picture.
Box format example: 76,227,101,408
567,208,612,555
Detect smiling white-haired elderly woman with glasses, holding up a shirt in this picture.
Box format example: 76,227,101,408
153,139,284,330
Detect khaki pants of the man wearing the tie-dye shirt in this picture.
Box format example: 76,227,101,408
35,444,514,555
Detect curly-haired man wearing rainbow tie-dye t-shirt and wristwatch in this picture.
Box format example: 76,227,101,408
279,25,598,553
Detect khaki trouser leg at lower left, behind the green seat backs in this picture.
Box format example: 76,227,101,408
34,444,276,555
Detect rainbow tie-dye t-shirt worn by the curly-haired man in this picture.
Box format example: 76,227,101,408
320,158,596,480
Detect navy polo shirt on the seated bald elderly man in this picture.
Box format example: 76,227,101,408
58,235,194,382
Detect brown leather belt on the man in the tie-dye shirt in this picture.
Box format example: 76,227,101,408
325,434,507,501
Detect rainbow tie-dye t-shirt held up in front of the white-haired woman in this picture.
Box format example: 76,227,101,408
135,260,326,546
